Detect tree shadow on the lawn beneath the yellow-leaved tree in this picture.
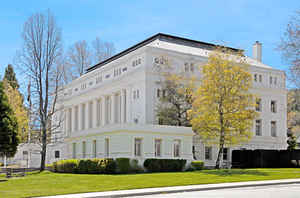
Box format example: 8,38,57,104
203,169,269,176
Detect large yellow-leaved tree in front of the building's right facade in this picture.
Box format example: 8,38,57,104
189,49,256,168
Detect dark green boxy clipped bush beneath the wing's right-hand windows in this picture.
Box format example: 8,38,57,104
144,159,186,172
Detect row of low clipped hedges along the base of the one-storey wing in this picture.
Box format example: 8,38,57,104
51,158,204,174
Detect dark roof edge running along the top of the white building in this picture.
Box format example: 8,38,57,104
86,33,244,73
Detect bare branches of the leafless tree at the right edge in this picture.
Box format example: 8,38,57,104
279,10,300,88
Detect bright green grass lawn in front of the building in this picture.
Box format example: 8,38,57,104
0,168,300,198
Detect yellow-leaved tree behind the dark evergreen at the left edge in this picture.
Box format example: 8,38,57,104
3,78,28,142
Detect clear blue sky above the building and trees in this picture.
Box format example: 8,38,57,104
0,0,300,84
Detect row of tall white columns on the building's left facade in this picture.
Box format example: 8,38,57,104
65,89,129,134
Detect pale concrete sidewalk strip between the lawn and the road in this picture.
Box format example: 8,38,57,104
41,179,300,198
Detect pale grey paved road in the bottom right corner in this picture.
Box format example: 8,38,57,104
132,184,300,198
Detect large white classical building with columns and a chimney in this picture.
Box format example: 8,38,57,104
48,33,287,166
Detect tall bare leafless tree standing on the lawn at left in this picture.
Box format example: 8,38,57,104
17,11,62,171
